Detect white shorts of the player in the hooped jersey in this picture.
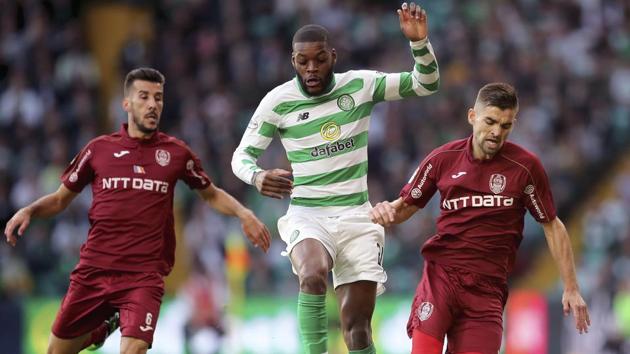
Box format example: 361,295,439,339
278,214,387,295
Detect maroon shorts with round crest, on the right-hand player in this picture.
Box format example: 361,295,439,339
407,261,508,354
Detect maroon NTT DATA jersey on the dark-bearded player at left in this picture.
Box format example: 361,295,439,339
61,124,212,275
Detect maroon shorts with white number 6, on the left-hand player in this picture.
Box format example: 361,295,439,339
52,266,164,345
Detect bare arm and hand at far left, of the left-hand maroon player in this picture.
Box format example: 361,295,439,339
4,184,78,247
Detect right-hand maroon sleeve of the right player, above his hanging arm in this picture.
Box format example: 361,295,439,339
523,159,556,223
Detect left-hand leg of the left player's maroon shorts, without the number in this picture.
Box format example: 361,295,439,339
52,277,116,340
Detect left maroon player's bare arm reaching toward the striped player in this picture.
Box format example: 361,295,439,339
199,185,271,252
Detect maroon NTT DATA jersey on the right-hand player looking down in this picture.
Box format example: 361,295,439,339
400,137,556,281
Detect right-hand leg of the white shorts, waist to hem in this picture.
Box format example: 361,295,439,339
333,215,387,293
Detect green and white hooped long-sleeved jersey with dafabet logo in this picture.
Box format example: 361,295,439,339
232,39,440,216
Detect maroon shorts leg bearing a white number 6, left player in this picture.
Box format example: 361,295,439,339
111,273,164,348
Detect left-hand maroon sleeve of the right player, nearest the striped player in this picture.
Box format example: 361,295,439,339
399,155,437,208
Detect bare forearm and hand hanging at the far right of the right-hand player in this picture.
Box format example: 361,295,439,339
542,217,591,334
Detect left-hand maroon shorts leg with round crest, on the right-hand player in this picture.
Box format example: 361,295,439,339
407,261,459,340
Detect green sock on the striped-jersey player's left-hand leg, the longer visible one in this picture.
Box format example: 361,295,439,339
297,292,328,354
